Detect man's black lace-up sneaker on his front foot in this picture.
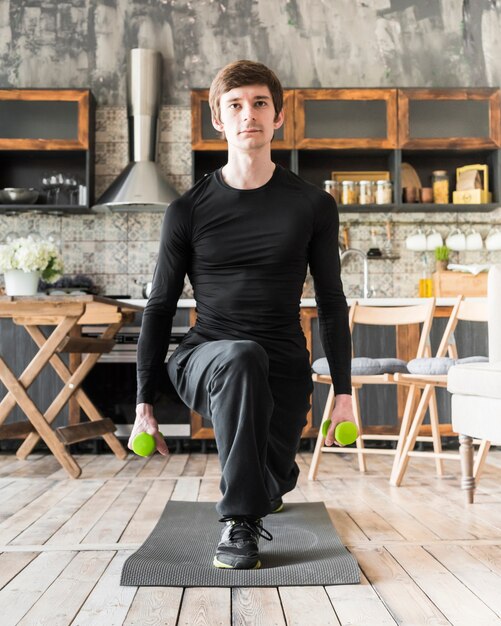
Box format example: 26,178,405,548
213,517,273,569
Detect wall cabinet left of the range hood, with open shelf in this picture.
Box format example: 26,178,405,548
0,89,95,214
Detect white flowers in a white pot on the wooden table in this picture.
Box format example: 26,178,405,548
0,236,63,296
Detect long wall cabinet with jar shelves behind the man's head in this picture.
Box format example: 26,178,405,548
192,89,501,213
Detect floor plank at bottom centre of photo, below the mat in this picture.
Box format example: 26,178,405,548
231,587,286,626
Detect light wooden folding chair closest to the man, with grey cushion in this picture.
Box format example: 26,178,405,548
308,298,435,480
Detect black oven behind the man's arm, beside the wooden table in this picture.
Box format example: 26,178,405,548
82,325,191,439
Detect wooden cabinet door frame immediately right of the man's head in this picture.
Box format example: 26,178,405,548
294,89,397,149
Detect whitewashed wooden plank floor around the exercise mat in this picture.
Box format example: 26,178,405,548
0,450,501,626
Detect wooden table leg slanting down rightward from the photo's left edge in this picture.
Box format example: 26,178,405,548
0,357,82,478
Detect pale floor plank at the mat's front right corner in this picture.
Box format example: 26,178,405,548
325,574,396,626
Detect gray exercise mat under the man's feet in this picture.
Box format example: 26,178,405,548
120,502,360,587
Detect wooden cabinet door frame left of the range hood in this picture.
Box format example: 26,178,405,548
0,89,90,150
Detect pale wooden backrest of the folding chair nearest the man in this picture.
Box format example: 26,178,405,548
349,298,435,358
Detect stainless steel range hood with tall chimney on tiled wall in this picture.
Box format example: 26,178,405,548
93,48,179,213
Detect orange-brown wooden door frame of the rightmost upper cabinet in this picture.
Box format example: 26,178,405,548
398,89,501,150
